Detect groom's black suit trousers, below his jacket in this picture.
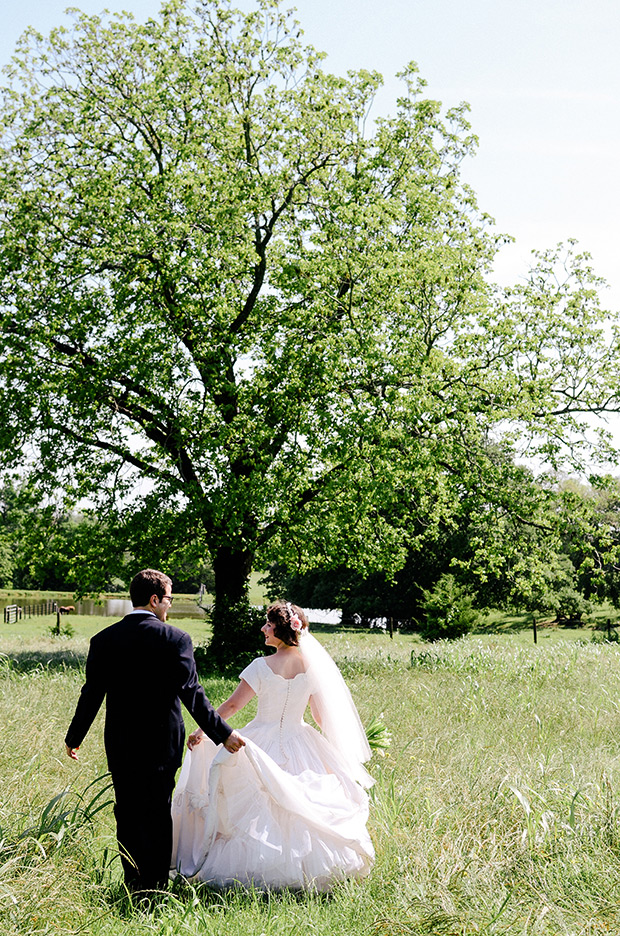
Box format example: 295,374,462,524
112,769,176,891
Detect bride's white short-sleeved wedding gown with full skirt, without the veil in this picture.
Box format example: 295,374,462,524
172,657,374,890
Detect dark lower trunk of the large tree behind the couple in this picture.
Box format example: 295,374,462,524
208,546,264,672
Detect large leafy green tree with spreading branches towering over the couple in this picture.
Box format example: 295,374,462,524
0,0,616,658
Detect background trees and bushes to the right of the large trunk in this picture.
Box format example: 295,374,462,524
270,471,620,638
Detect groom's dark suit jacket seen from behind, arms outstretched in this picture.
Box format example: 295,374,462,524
65,612,231,774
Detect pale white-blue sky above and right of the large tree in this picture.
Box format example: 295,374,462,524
0,0,620,454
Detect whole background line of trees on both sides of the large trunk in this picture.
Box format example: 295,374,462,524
0,470,620,638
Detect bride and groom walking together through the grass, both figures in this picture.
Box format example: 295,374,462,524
65,569,374,892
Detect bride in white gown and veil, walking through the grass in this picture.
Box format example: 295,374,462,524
172,602,374,891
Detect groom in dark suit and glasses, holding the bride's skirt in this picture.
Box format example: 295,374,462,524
65,569,244,891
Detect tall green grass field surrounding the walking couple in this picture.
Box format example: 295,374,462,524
0,617,620,936
